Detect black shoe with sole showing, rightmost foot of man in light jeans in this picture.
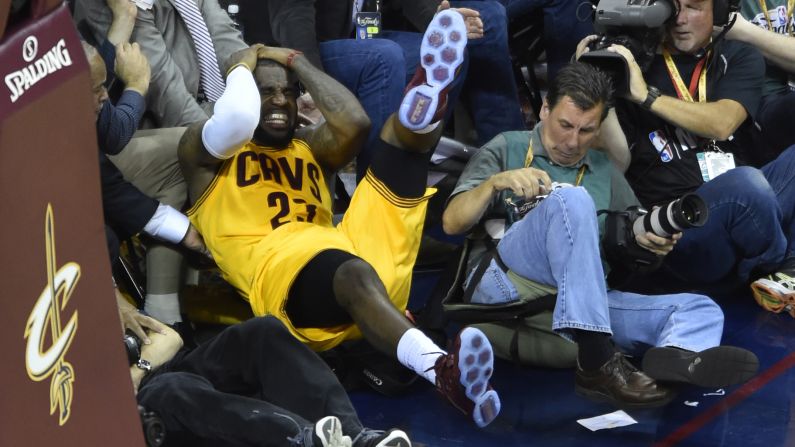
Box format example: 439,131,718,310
643,346,759,388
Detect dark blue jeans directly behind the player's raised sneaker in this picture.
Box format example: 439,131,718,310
381,0,525,145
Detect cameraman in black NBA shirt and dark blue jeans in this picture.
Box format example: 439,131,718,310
577,0,795,316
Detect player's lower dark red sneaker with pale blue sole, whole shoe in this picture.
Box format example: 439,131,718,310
434,327,500,427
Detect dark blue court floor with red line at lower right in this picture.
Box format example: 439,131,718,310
351,273,795,447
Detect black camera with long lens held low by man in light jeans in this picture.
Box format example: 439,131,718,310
599,193,709,273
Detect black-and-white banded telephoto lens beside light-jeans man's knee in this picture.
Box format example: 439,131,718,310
632,193,709,237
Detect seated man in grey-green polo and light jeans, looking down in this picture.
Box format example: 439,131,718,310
443,62,758,407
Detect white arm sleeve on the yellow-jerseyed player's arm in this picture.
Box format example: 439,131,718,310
202,65,260,160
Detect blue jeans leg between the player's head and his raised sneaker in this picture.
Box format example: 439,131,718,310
320,39,404,180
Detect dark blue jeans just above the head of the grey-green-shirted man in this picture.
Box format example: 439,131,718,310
470,0,594,79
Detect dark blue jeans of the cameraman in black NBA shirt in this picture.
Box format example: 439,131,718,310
660,147,795,288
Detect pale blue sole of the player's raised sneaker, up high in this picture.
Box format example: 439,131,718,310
398,9,467,130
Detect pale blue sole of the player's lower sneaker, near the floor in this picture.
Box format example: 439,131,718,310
458,327,501,427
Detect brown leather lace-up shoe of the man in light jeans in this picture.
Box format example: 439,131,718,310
574,352,674,408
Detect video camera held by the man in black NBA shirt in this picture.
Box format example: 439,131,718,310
580,0,678,95
